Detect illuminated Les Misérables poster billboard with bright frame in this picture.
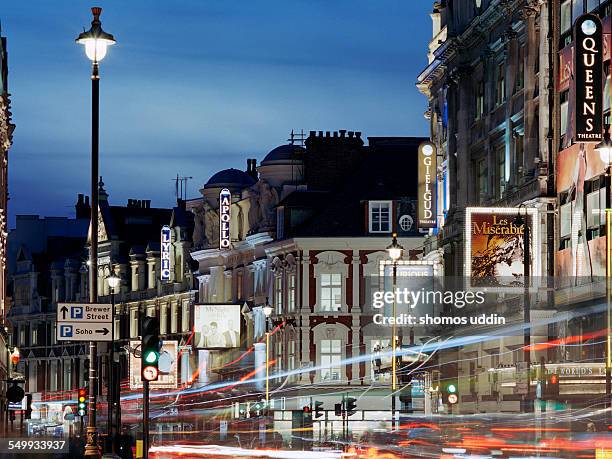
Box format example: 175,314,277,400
465,207,540,290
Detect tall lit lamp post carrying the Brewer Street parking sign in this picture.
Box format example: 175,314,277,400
76,7,115,457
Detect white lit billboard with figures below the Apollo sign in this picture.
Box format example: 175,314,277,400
194,304,240,349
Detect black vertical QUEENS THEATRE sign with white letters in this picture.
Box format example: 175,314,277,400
574,14,603,142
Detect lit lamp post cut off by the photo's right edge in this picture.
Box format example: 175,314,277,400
595,125,612,416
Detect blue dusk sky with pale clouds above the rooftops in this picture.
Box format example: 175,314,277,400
0,0,432,222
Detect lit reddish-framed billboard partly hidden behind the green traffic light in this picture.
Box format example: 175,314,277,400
130,340,178,389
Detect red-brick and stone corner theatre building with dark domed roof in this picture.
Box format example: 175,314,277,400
188,131,442,440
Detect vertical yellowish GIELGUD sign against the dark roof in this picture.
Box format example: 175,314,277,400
418,142,437,228
